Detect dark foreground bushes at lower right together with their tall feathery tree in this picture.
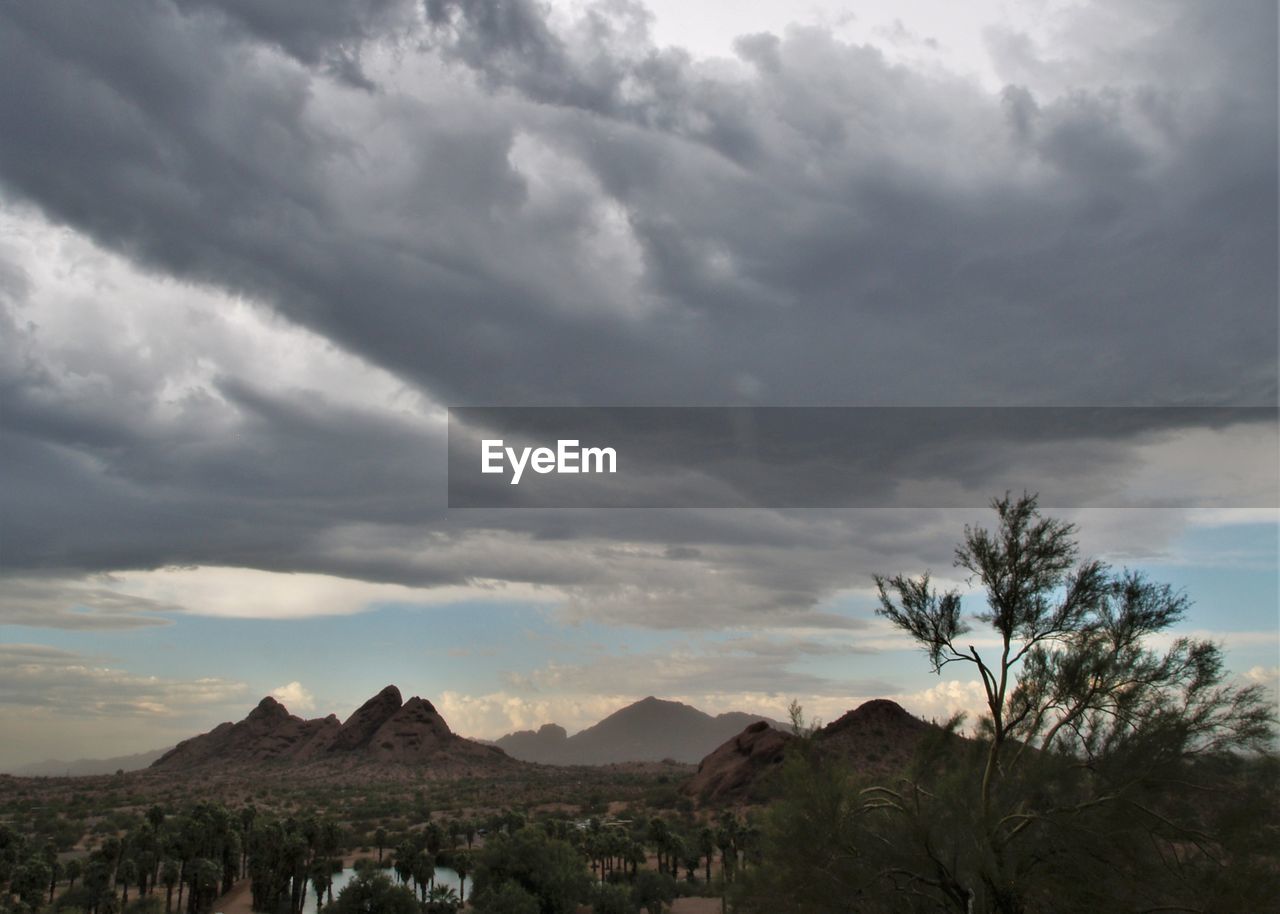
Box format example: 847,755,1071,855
740,495,1280,914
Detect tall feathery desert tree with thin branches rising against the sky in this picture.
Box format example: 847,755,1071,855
867,494,1271,914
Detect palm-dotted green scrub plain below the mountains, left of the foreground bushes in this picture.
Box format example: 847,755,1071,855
0,773,759,914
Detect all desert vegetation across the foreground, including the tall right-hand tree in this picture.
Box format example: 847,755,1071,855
0,495,1280,914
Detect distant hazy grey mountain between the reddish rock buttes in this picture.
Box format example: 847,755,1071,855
494,696,774,764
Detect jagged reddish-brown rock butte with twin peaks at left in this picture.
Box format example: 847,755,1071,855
151,685,512,771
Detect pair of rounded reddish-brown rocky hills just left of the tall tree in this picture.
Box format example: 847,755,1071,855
684,699,938,803
